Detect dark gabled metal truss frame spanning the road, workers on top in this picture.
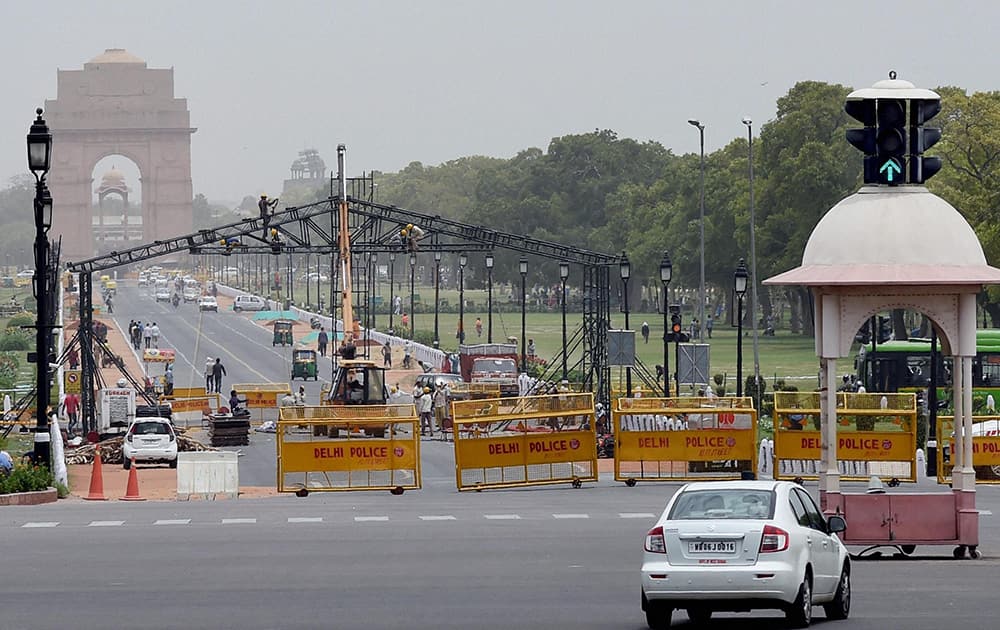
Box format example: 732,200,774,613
67,177,620,430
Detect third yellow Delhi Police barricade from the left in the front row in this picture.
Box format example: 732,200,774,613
611,397,757,486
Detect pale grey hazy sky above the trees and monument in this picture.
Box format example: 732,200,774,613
0,0,1000,201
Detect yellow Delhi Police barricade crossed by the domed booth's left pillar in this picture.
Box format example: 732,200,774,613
774,392,917,481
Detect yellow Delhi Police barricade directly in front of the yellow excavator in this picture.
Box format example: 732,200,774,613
275,405,421,496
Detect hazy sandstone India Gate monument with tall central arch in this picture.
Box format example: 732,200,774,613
44,48,196,260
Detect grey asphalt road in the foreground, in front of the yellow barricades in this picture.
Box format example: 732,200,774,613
0,484,1000,630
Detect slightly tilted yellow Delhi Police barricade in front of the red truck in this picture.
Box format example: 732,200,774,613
451,393,597,490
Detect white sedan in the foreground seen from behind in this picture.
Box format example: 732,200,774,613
642,481,851,628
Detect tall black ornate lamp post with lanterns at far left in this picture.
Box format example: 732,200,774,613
28,108,54,467
